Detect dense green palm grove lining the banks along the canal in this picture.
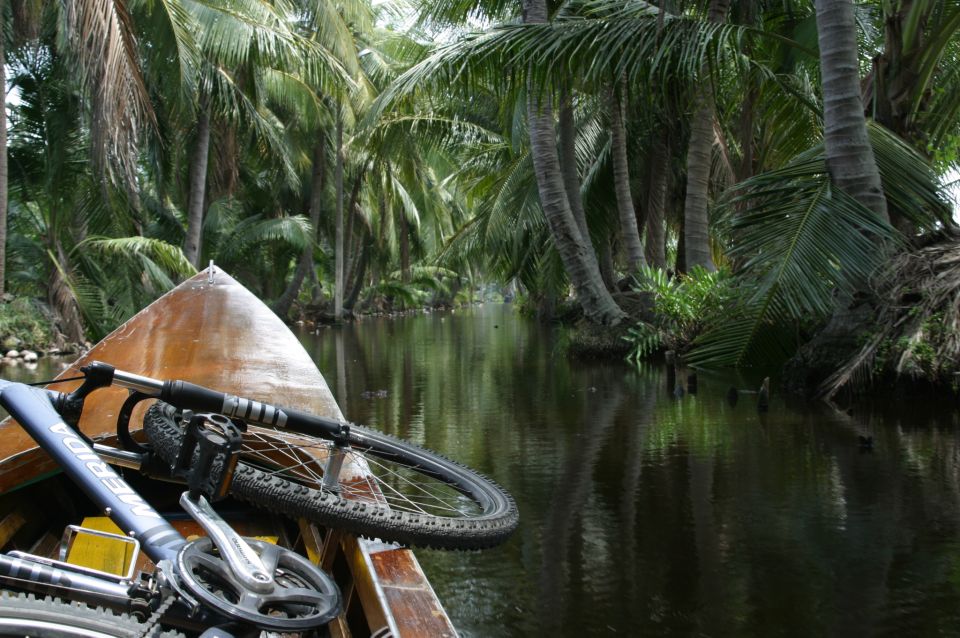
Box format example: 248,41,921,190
0,0,960,392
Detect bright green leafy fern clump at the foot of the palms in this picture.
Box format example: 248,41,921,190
627,266,734,363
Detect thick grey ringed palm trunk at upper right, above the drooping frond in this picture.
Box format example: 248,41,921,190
816,0,890,221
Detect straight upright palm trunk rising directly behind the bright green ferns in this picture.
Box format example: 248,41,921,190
683,0,730,270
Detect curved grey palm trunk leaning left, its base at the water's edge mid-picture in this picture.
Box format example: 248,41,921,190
523,0,626,325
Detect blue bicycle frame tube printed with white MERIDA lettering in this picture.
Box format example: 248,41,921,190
0,381,186,563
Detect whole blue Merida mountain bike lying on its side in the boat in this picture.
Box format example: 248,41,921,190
0,362,518,636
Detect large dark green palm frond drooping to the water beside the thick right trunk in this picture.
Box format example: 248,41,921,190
689,159,897,366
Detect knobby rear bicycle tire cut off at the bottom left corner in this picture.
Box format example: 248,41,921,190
0,591,183,638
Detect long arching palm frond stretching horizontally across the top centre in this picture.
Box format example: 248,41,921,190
379,0,753,117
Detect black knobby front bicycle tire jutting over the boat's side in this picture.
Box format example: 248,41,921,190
144,402,519,549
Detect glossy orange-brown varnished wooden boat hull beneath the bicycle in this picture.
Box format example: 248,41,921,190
0,269,456,638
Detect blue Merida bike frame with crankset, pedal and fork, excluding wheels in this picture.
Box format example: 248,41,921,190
0,363,349,635
